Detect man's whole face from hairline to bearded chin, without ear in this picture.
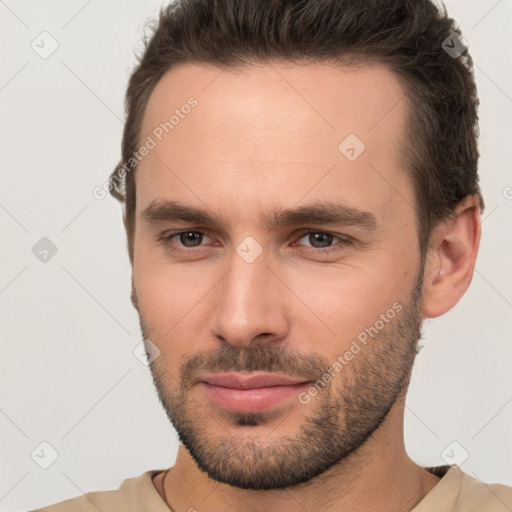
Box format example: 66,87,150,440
134,63,423,489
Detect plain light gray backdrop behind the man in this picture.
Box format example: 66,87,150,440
0,0,512,511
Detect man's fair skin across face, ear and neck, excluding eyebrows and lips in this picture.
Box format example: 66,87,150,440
127,62,480,512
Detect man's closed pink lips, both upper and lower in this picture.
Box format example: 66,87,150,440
200,373,311,412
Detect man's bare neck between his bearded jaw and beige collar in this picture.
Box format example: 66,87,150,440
155,399,439,512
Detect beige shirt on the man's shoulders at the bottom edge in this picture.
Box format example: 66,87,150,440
32,466,512,512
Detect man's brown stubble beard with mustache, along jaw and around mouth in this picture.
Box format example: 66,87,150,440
139,272,423,490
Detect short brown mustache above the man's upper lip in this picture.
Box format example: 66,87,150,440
180,344,330,388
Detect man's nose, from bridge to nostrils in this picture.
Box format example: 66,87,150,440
210,247,290,348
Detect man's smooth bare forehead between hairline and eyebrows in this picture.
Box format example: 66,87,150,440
136,62,408,229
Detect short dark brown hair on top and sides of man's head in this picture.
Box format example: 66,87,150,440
109,0,484,264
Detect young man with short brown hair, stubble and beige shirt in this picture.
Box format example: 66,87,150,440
34,0,512,512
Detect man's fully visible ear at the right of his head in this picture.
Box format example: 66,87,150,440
422,195,481,318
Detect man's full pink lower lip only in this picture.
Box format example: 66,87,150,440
203,382,309,412
